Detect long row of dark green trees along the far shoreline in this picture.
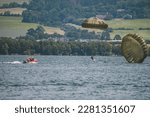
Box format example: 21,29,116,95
0,37,121,56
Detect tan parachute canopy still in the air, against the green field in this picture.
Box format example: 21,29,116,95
82,17,108,29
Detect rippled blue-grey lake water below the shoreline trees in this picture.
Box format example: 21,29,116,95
0,55,150,100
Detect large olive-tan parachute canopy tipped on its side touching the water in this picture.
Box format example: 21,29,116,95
121,34,148,63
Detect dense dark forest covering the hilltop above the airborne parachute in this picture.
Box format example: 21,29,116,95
22,0,150,26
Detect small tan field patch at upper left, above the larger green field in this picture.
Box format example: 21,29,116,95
0,8,26,15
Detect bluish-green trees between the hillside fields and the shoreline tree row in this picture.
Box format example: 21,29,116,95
20,25,112,41
